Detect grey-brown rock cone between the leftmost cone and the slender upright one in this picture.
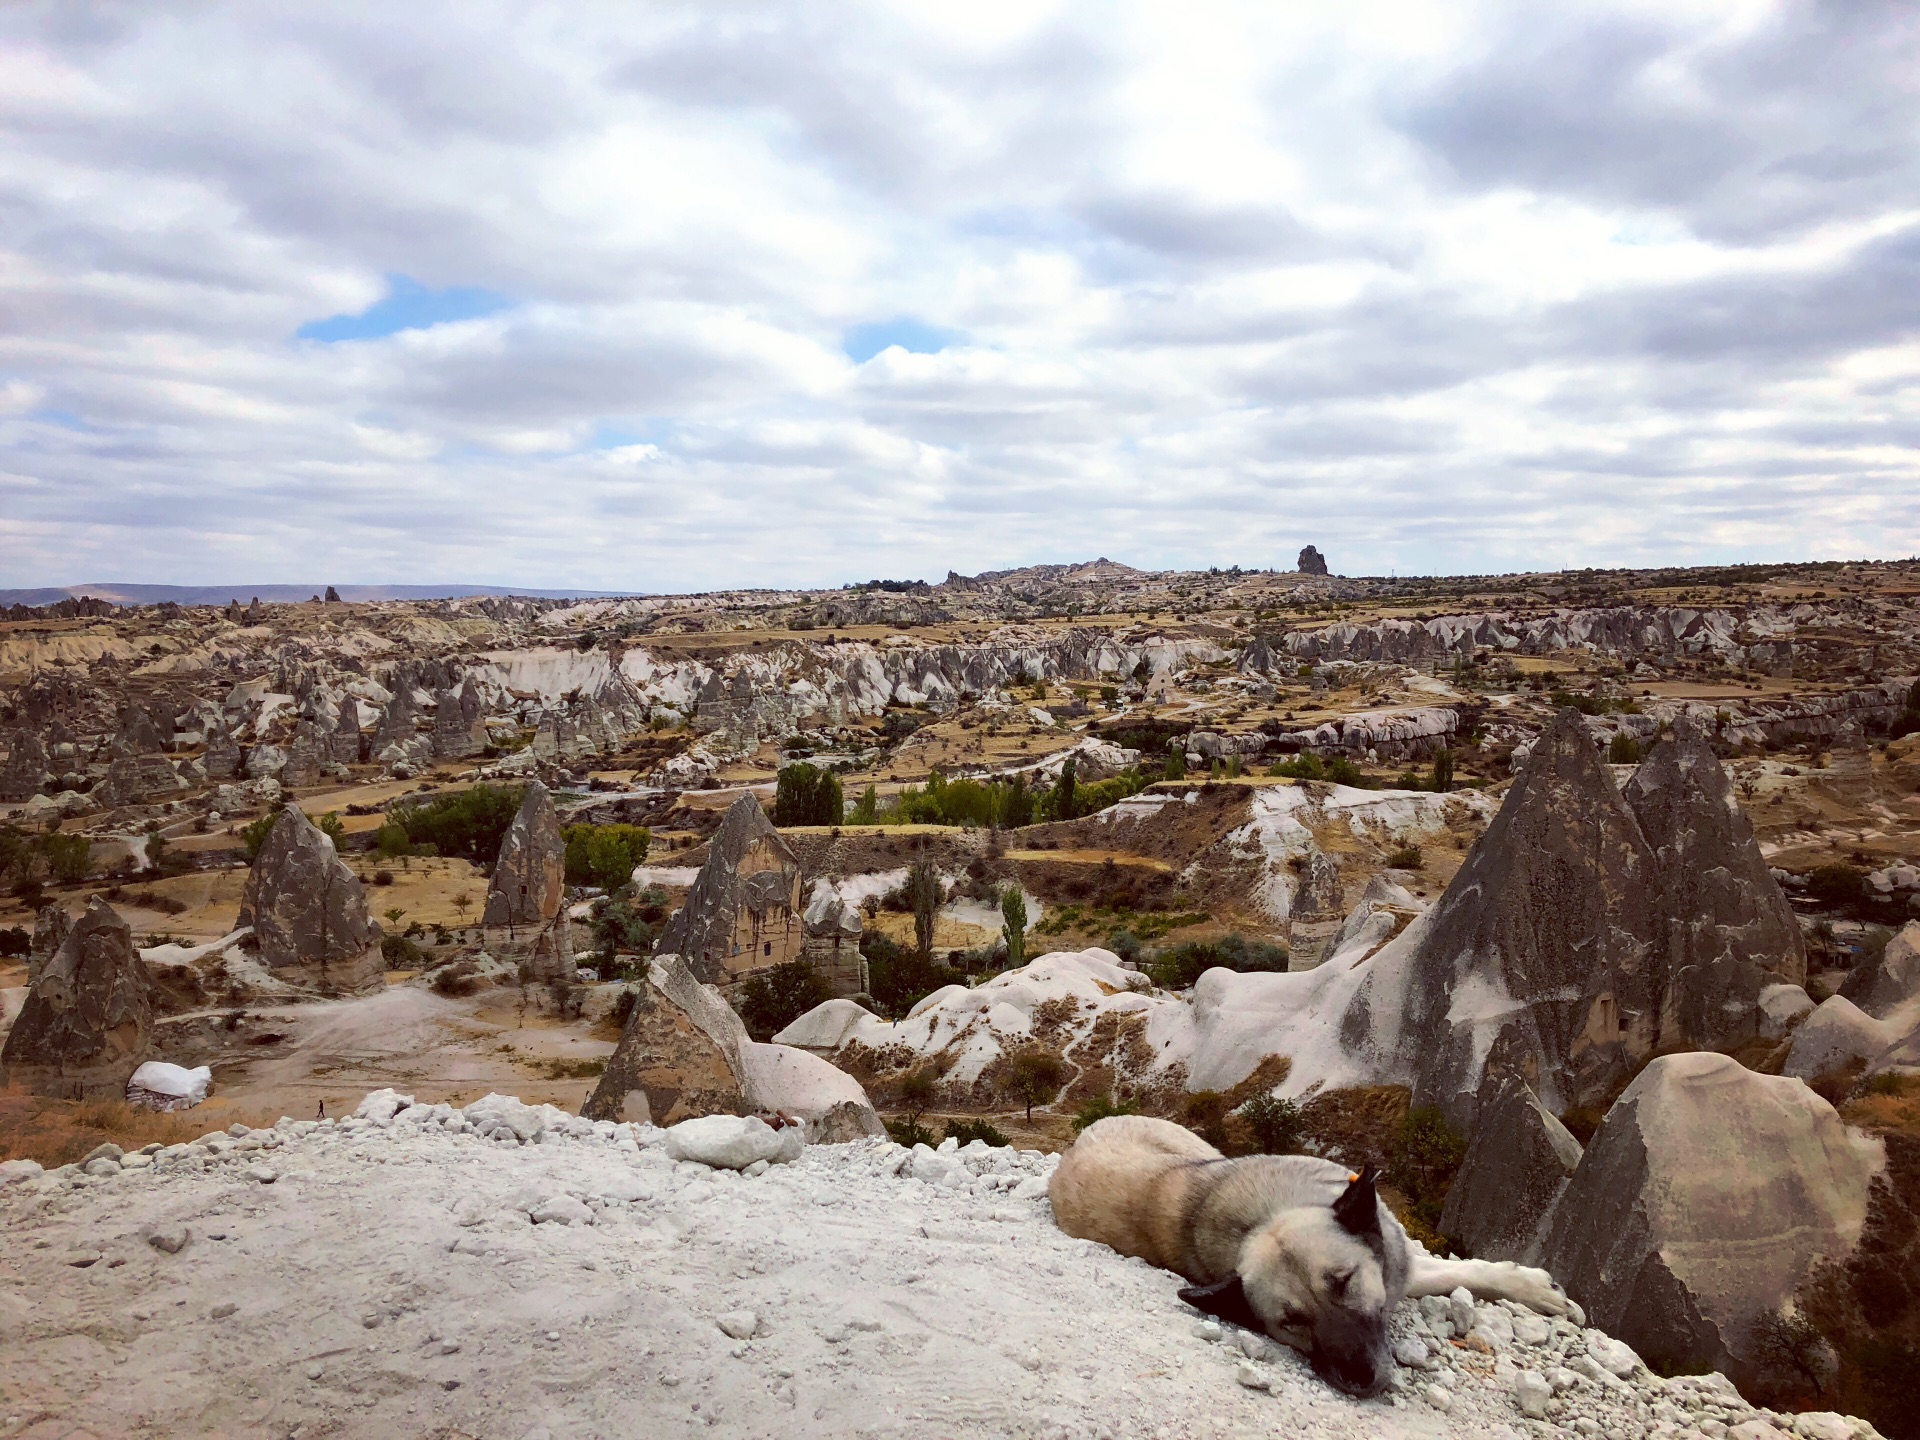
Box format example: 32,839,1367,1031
238,804,382,995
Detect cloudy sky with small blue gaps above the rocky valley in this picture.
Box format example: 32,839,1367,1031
0,0,1920,589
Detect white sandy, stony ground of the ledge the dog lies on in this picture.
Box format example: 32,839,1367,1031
0,1106,1864,1440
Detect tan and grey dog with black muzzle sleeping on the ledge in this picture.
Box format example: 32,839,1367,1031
1046,1116,1572,1396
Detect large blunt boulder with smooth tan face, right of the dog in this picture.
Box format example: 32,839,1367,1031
1542,1052,1880,1384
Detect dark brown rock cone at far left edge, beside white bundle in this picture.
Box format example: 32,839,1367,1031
0,897,154,1100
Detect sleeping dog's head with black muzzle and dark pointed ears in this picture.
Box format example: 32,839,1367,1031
1181,1165,1405,1396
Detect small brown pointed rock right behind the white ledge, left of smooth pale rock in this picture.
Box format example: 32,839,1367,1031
580,954,749,1125
